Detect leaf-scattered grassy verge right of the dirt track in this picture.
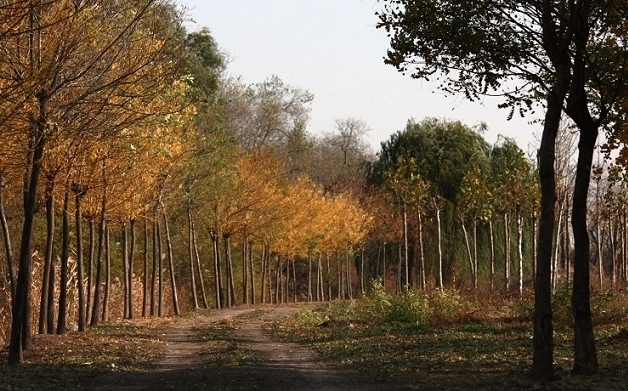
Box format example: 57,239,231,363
271,287,628,391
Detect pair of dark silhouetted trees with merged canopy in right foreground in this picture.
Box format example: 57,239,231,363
379,0,626,380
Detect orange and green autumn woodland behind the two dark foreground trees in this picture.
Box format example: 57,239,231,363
0,0,628,386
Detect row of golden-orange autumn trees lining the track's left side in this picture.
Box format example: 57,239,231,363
0,0,371,363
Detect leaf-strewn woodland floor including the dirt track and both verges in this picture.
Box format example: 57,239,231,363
0,306,628,391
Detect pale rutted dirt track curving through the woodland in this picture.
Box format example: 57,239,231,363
96,307,413,391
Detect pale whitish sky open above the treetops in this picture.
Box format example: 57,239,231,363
177,0,541,152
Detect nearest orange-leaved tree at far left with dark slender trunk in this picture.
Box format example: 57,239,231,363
0,0,186,363
